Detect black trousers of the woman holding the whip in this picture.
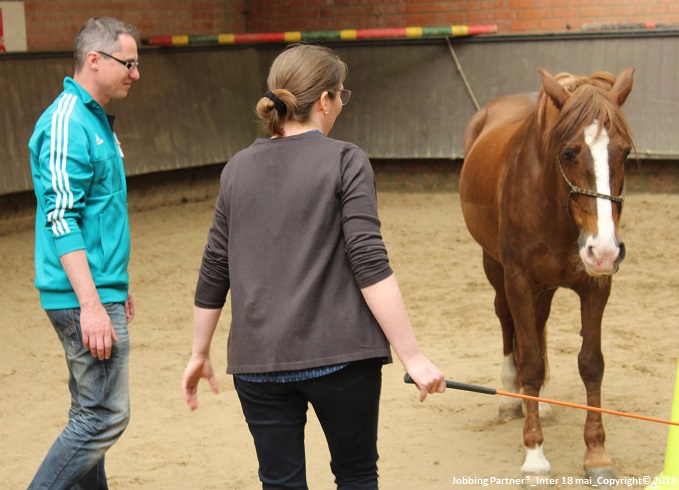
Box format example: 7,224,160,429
234,359,382,490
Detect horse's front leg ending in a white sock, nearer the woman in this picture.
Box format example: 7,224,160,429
505,271,551,475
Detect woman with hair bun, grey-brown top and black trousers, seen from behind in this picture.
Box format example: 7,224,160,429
182,44,445,489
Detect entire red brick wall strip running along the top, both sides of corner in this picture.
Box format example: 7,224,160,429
15,0,679,51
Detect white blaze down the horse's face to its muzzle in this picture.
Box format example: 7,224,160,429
581,121,620,274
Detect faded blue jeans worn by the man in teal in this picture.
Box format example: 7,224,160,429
28,303,130,490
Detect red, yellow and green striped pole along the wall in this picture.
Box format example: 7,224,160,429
144,24,497,46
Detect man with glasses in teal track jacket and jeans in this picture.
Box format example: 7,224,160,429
28,17,139,489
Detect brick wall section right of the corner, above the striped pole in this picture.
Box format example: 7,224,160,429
245,0,679,34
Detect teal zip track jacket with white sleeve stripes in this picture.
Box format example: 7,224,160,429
28,77,130,310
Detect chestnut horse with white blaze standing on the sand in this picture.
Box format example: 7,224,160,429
460,68,634,483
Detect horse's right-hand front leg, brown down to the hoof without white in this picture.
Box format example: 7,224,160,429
578,278,615,481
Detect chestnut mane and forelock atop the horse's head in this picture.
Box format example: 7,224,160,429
537,71,632,154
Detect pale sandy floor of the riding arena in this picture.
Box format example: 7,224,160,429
0,164,679,490
